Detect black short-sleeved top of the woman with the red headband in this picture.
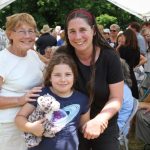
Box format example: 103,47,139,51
75,49,123,124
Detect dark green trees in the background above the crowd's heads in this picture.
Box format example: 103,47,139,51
0,0,142,29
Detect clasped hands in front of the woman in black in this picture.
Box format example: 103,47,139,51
82,116,108,140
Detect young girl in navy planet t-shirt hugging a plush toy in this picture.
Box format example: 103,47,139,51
16,53,89,150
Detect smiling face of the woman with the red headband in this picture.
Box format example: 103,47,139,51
67,18,94,52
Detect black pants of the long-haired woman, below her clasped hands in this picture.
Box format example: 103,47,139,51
79,125,119,150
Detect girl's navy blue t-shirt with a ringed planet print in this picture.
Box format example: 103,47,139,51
29,87,89,150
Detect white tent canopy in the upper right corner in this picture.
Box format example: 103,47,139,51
107,0,150,21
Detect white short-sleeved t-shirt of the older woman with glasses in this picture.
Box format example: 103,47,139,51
0,49,45,123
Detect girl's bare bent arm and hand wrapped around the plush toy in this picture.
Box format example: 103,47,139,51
15,103,45,136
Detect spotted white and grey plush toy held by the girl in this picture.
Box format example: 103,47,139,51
24,95,63,147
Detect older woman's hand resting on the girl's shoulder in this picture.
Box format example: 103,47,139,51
18,87,42,106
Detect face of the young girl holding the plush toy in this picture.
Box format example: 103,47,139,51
50,64,74,97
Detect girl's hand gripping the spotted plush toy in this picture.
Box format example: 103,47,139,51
30,118,46,136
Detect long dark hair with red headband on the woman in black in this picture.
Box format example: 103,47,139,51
65,8,111,104
